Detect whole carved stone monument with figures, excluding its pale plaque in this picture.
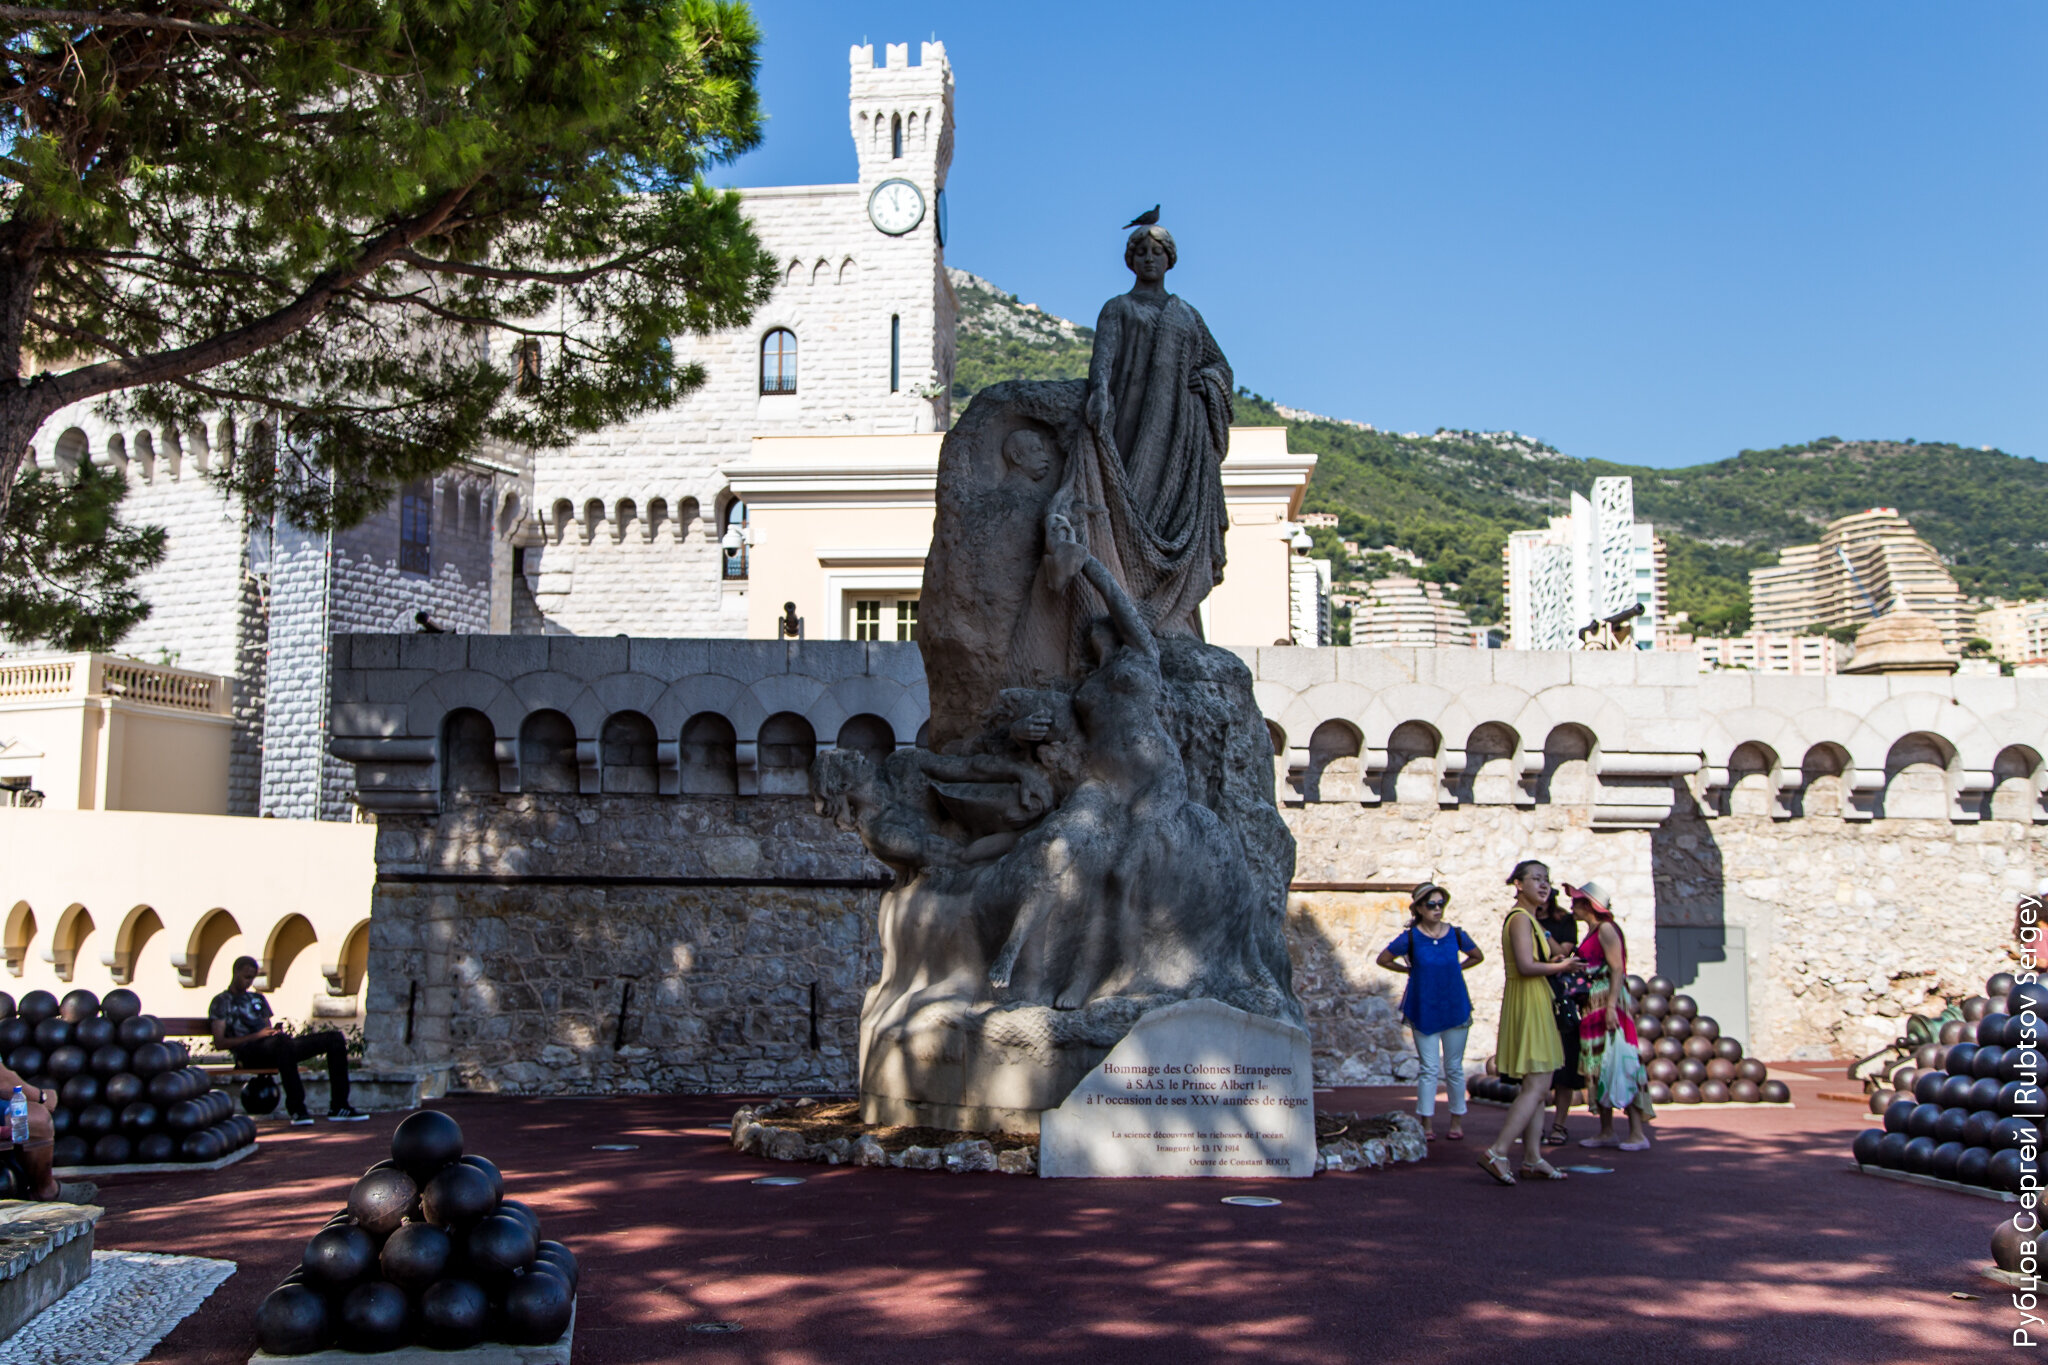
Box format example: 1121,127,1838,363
813,227,1303,1132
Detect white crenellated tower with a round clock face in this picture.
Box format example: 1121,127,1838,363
848,43,956,430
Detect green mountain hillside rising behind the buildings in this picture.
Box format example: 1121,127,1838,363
952,270,2048,634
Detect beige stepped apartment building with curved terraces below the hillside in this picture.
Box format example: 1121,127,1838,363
1749,508,1972,653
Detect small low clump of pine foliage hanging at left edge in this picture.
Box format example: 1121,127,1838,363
0,465,164,651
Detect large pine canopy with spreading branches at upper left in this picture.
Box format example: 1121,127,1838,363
0,0,774,526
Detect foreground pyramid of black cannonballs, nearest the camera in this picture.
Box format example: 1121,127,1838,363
256,1109,578,1355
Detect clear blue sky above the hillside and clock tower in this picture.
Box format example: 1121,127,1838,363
715,0,2048,465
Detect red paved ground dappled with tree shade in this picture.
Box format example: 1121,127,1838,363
88,1068,2017,1365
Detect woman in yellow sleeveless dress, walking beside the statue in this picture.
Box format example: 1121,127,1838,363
1479,860,1581,1185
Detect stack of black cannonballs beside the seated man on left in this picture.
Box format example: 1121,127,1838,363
0,990,256,1166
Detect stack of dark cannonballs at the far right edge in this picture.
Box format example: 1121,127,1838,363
1853,972,2048,1193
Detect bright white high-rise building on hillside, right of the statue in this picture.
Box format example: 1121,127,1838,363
1503,477,1665,649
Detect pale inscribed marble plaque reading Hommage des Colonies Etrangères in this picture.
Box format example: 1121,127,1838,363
1038,999,1315,1179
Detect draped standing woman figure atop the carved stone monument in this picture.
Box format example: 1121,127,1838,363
1047,227,1233,636
